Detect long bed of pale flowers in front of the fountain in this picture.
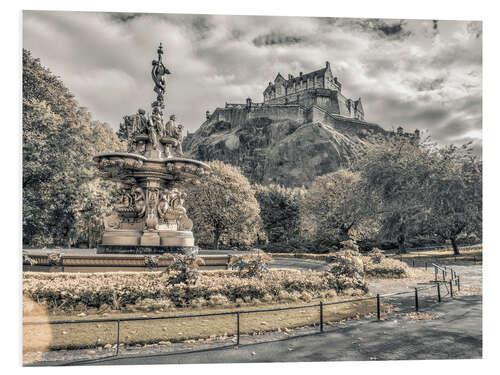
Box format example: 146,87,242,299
23,270,368,311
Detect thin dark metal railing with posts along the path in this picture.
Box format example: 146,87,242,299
23,263,460,363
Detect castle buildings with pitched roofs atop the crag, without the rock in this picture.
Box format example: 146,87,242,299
263,61,365,121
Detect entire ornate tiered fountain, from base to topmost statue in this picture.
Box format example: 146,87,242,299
94,43,210,254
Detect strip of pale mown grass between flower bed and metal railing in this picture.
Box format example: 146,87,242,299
23,296,376,352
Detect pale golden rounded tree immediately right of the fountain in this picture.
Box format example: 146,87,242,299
186,161,265,249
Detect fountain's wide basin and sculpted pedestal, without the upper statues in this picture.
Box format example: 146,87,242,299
94,153,209,254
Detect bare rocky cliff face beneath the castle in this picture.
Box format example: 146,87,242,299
183,109,385,187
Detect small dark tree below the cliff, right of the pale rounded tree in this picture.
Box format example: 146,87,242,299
254,184,305,245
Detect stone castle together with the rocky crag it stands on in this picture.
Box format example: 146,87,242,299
182,62,420,186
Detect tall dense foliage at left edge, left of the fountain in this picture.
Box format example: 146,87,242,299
23,50,123,246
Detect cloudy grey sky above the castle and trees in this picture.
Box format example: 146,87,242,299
23,11,482,152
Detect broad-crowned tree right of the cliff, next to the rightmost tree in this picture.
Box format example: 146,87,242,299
354,135,436,253
